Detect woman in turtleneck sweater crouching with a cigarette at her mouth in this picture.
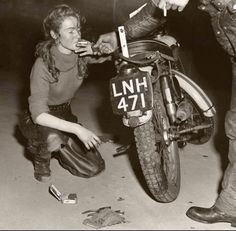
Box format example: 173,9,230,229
20,5,108,181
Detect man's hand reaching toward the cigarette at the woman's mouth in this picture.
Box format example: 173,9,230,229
94,32,118,54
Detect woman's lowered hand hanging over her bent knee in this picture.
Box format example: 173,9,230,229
74,124,101,150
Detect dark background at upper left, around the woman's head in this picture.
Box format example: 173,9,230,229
0,0,148,69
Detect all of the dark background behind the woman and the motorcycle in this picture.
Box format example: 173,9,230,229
0,0,231,88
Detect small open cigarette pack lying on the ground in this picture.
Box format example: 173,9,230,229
49,184,78,204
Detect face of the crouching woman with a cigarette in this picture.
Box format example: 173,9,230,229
57,16,81,54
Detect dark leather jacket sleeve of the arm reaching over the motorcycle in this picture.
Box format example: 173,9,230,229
124,0,166,40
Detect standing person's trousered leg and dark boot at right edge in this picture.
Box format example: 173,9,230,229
186,63,236,227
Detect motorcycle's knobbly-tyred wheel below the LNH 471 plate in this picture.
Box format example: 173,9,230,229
134,83,181,203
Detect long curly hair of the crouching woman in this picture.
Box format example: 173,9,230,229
35,4,88,82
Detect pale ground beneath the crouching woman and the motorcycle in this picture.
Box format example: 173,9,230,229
0,72,234,230
